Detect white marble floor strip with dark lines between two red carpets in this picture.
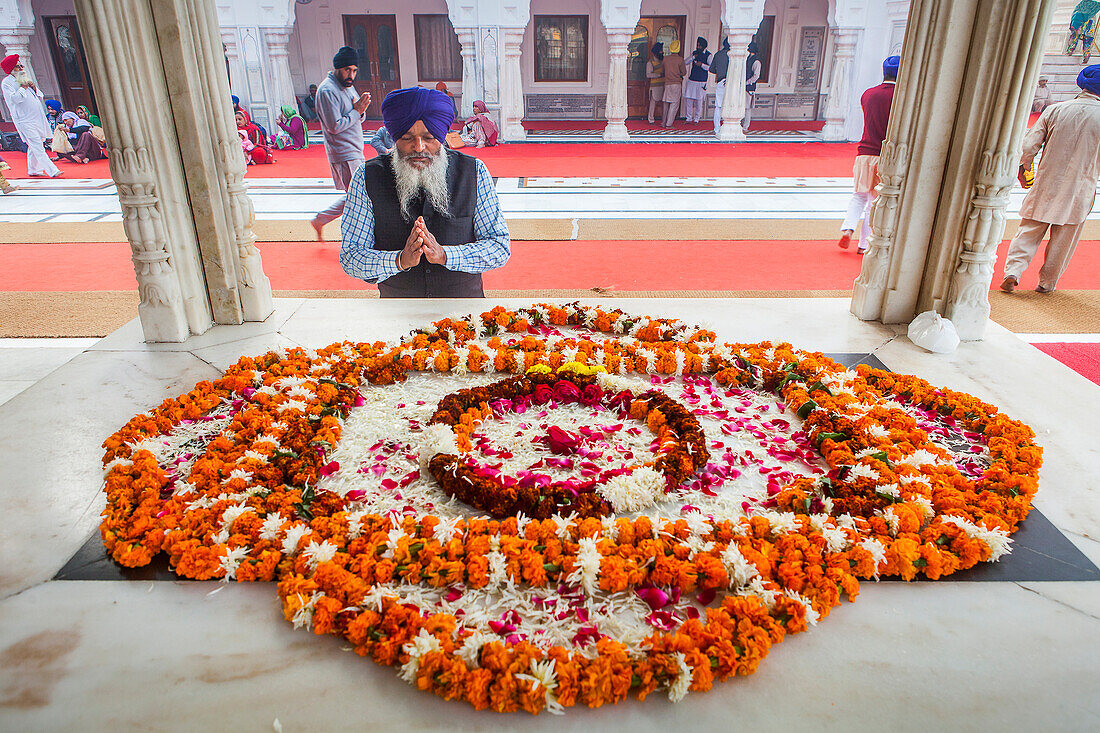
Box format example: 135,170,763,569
0,176,1064,223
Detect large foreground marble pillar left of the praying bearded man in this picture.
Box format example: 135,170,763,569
76,0,272,341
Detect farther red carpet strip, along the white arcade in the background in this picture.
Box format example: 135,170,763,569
3,142,856,179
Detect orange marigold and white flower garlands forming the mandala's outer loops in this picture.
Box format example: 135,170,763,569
100,304,1042,713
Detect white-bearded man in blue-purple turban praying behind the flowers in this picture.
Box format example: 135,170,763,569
340,87,512,298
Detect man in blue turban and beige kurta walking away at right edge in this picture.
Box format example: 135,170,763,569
1001,64,1100,293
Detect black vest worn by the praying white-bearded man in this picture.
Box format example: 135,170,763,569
363,147,485,298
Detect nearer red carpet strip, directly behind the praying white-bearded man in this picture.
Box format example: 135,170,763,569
8,235,1100,292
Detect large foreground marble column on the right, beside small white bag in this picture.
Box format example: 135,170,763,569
851,0,1056,339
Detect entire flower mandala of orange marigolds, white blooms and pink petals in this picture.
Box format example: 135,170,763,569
101,304,1042,713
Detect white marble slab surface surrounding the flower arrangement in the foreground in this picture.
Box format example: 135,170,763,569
0,299,1100,732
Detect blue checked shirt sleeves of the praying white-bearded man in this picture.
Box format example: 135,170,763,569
340,161,512,283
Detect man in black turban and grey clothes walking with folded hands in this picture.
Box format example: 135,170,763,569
311,46,371,241
